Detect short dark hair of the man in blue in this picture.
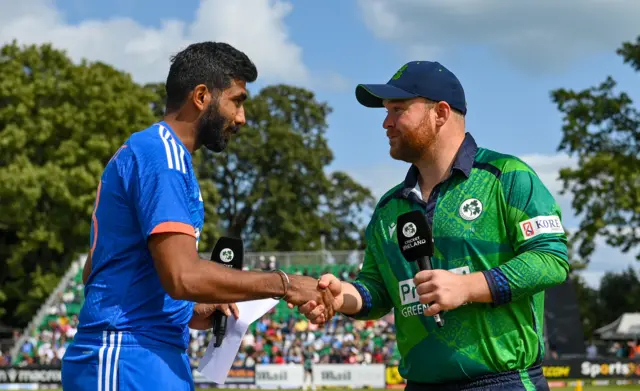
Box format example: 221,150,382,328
165,42,258,112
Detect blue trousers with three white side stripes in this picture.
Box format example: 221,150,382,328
62,331,195,391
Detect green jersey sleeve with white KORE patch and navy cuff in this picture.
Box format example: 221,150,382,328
484,160,569,306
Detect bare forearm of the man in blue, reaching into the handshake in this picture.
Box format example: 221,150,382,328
175,259,287,304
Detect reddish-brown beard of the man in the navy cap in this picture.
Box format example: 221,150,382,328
389,117,436,164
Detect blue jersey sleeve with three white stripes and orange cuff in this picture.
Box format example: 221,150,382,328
128,132,196,238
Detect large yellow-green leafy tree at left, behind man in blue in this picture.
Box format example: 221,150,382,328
0,42,217,326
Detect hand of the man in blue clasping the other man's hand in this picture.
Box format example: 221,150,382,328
285,275,342,320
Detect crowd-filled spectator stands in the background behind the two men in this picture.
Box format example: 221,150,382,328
13,264,399,367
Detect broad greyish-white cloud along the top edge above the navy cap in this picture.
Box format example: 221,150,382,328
358,0,640,73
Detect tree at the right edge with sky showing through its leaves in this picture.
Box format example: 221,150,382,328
551,37,640,262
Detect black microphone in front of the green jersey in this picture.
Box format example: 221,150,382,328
396,210,444,327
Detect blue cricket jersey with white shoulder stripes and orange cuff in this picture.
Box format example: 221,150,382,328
78,122,204,349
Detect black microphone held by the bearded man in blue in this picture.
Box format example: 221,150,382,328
211,236,244,348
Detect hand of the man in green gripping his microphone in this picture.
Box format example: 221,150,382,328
413,270,470,316
